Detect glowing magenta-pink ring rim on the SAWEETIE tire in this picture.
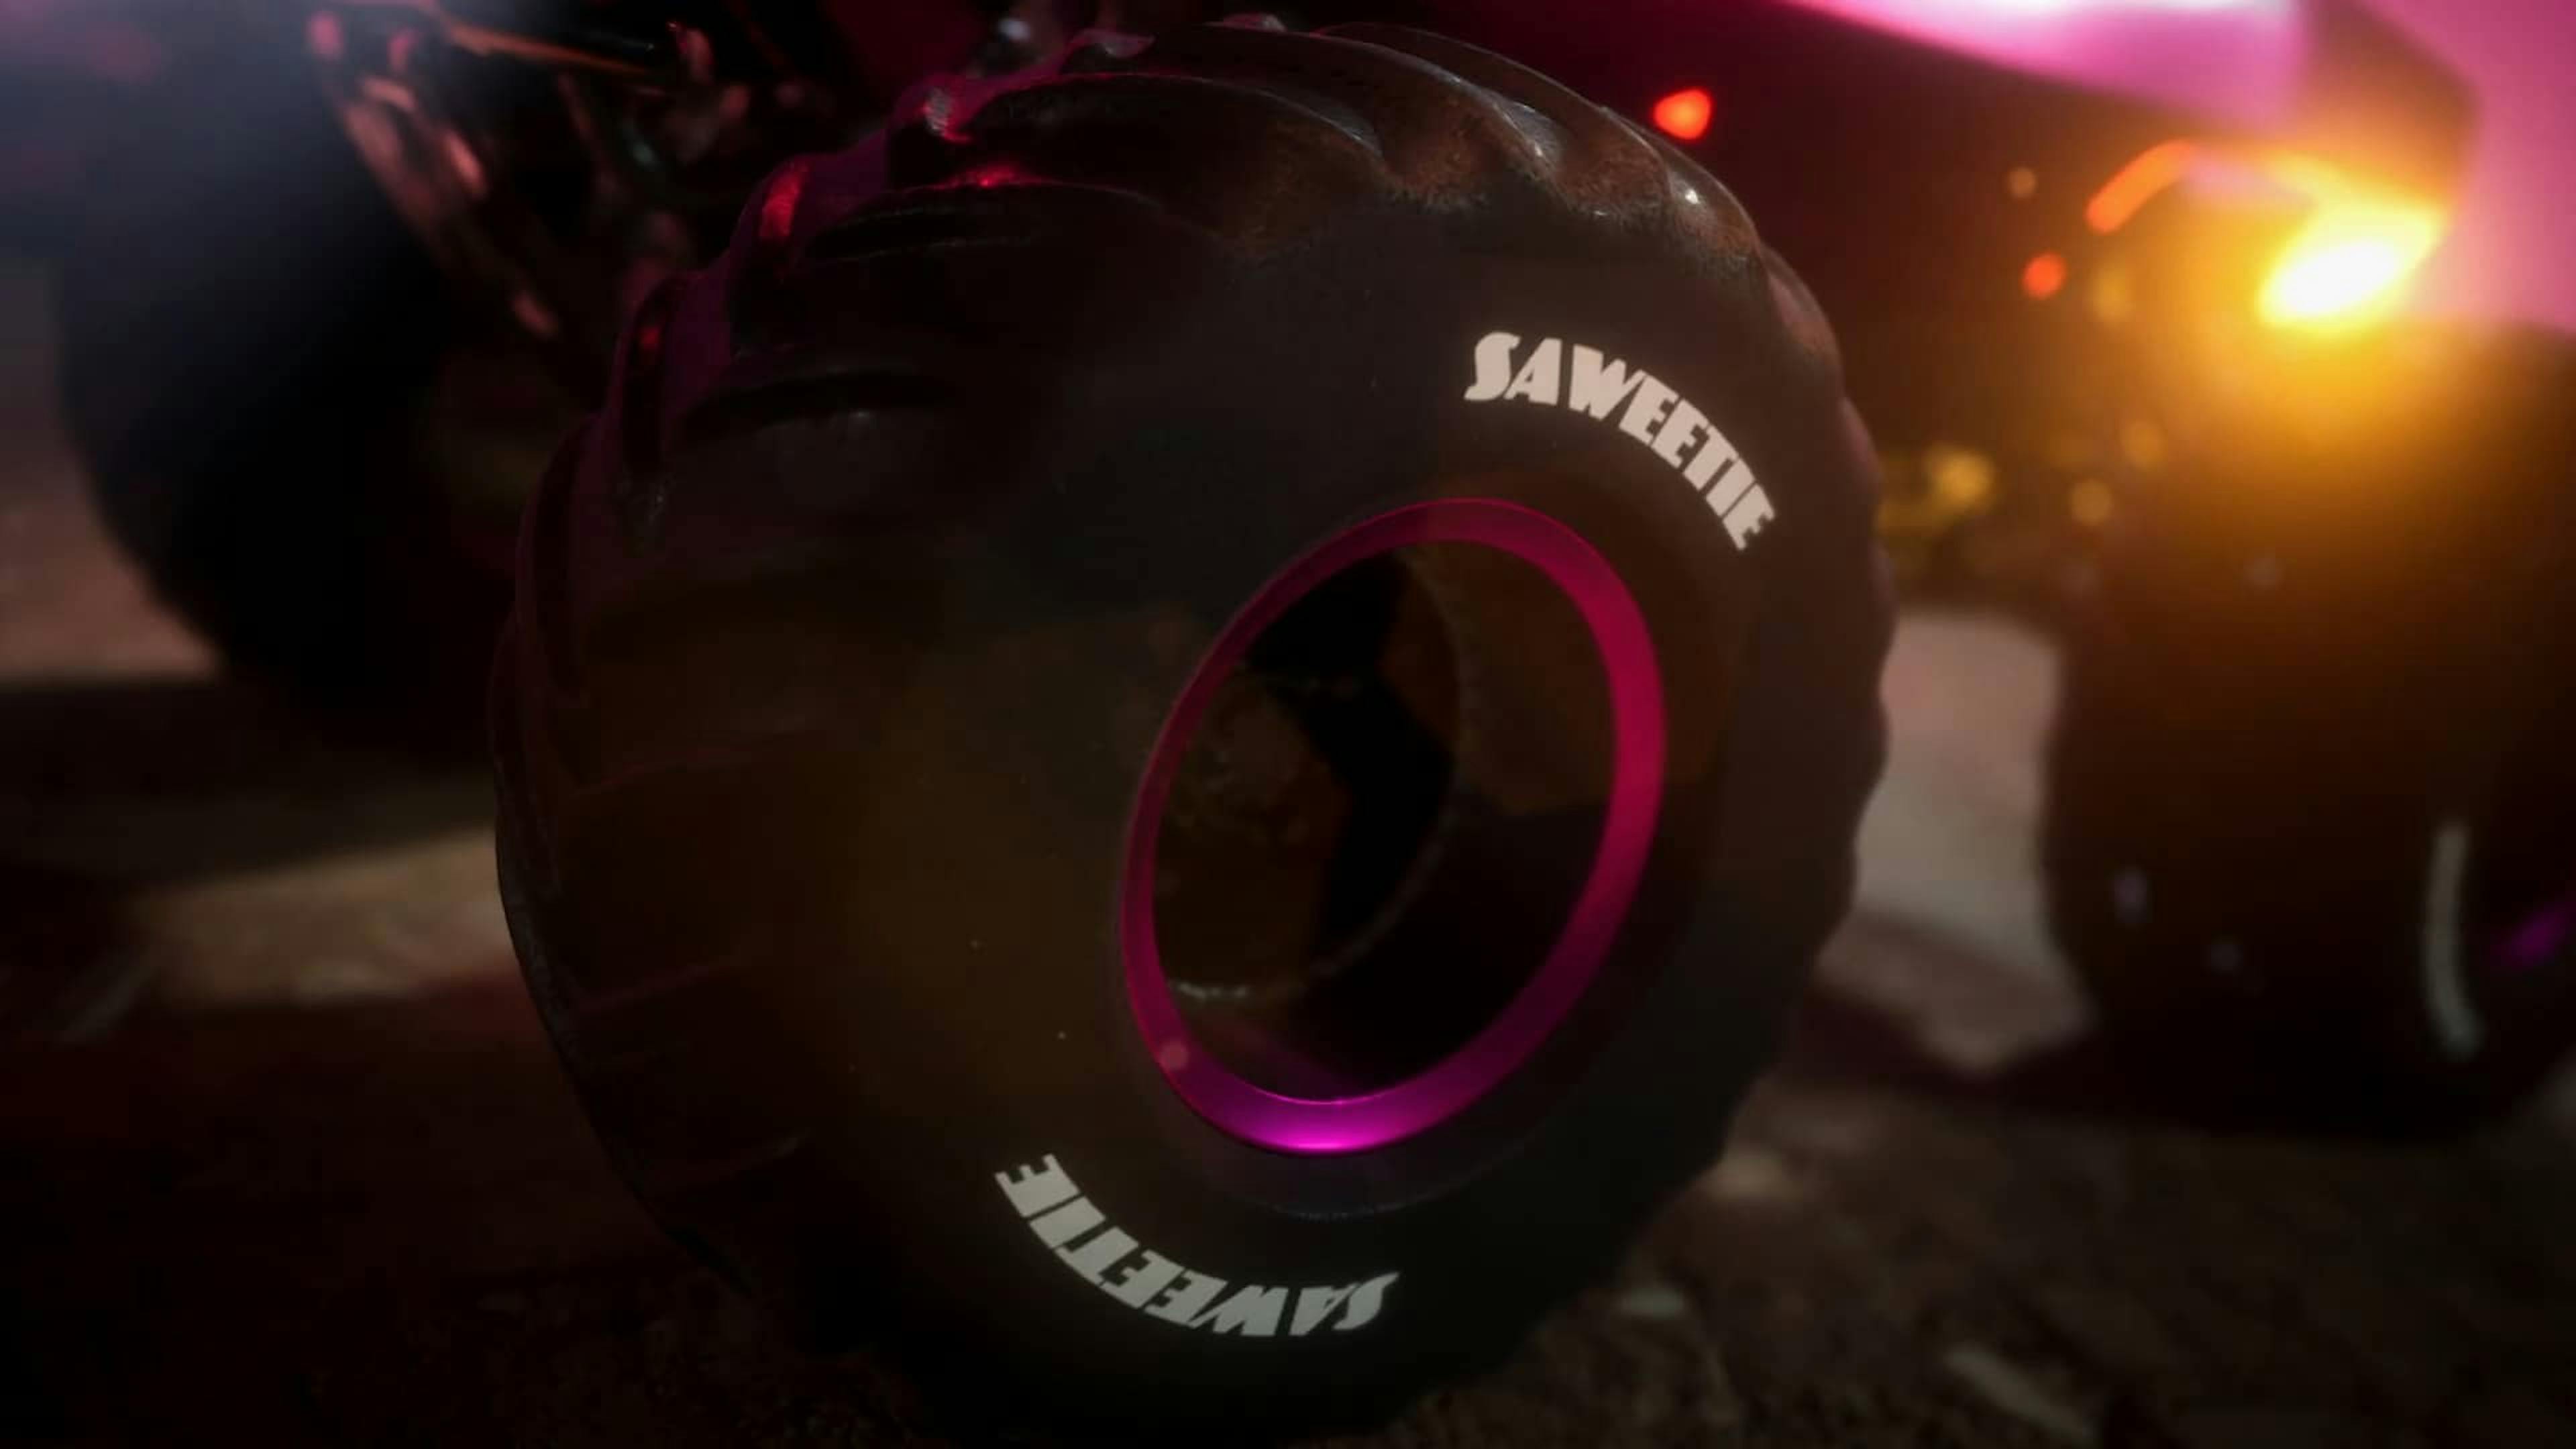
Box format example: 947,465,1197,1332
1118,498,1664,1152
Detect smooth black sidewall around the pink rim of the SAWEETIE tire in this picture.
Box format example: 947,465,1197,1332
664,222,1883,1385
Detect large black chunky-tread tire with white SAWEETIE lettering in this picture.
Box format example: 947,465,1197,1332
492,25,1891,1428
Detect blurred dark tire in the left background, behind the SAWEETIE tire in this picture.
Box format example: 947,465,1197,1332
54,28,510,743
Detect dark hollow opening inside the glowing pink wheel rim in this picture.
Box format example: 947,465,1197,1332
1151,541,1618,1101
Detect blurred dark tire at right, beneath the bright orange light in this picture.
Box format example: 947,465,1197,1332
2043,333,2576,1132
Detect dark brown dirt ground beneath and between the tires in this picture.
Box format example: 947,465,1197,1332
0,262,2576,1449
